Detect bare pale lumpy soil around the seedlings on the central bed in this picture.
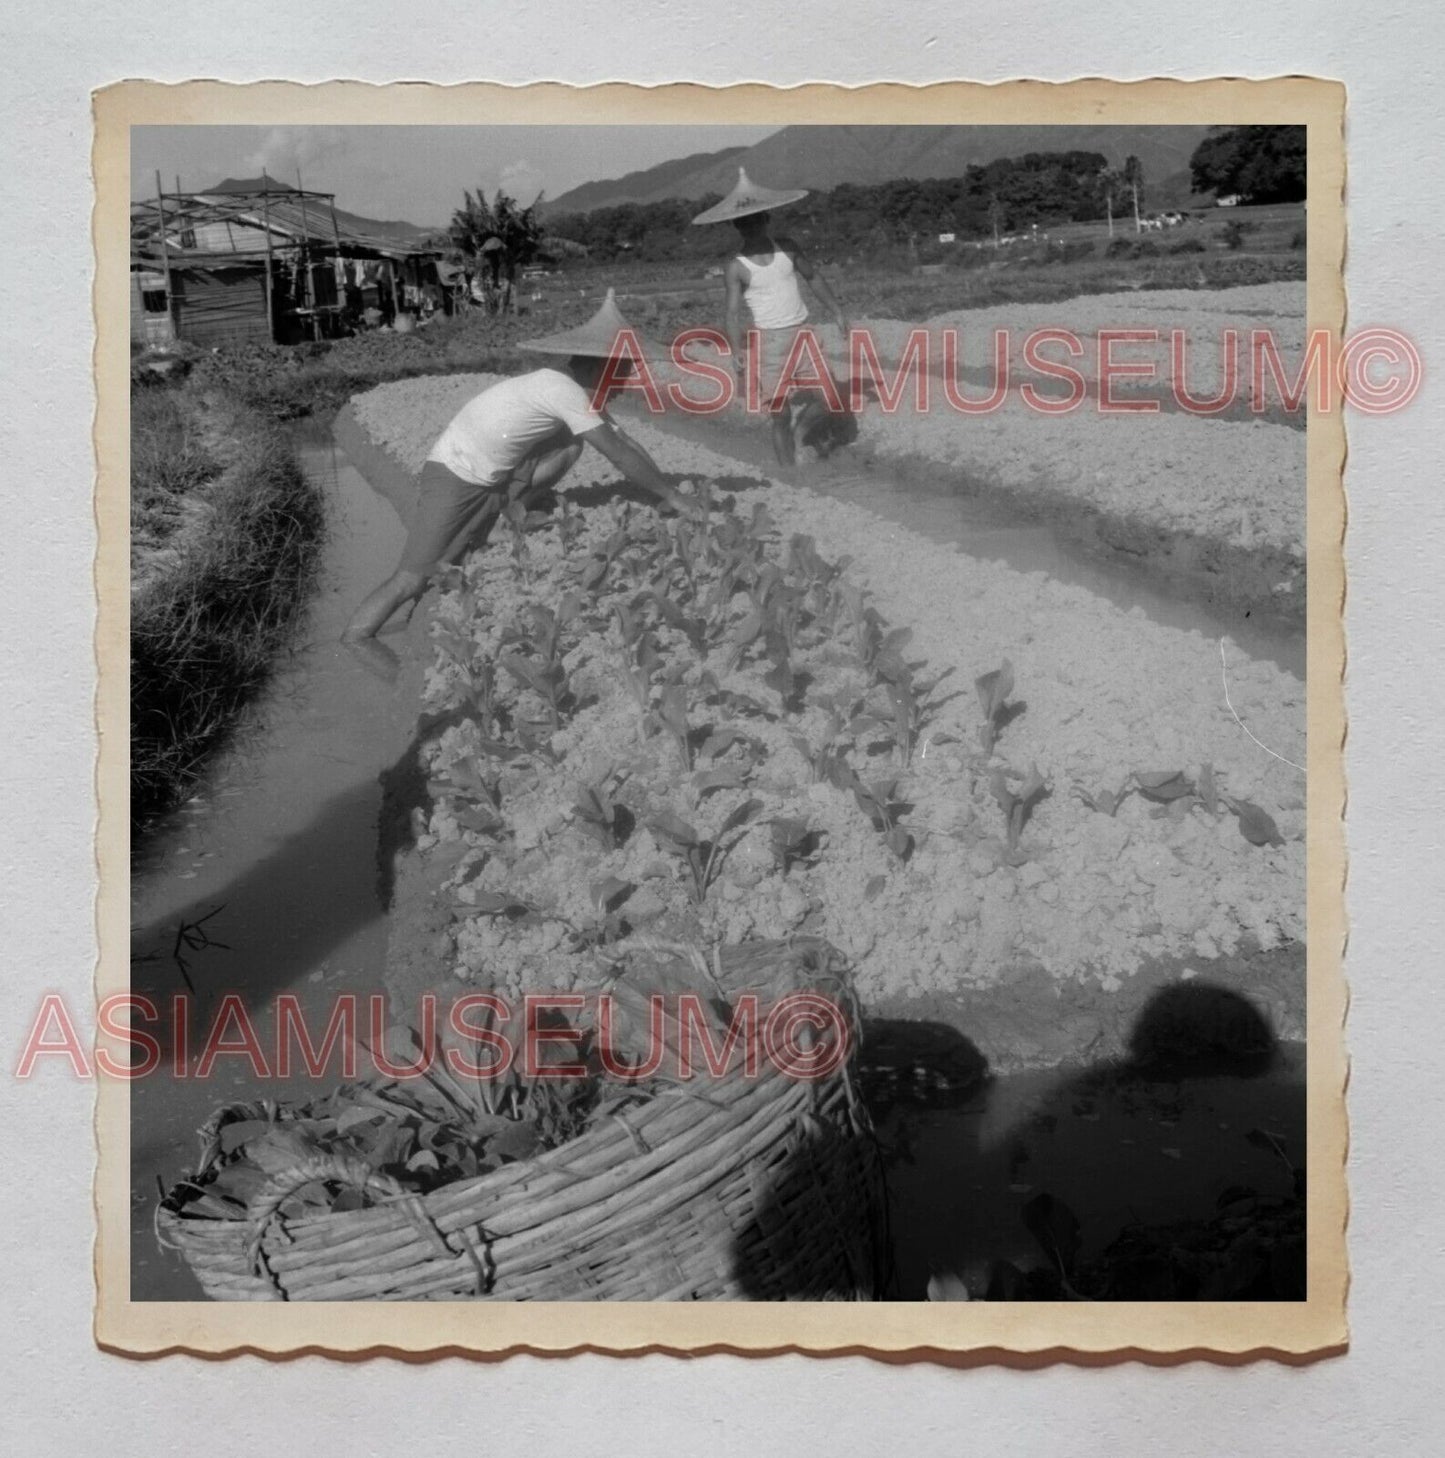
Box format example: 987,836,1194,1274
354,378,1304,1070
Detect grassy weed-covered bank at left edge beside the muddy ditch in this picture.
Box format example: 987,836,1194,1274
130,385,325,834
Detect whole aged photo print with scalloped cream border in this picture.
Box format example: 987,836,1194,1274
93,77,1368,1363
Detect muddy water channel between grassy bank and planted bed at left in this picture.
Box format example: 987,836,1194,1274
131,432,416,1301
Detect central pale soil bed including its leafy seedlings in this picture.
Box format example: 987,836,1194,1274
343,376,1305,1072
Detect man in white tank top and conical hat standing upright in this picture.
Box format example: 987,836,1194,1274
693,168,857,465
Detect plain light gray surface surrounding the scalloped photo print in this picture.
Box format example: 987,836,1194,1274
0,0,1445,1458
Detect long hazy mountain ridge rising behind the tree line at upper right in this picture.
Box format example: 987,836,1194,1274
541,127,1209,217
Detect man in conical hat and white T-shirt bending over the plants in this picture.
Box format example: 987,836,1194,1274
341,289,698,643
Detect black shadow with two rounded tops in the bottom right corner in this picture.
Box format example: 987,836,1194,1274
735,980,1305,1301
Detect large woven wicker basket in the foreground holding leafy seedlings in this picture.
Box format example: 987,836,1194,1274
156,940,888,1301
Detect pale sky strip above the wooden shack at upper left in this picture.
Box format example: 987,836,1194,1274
131,125,777,227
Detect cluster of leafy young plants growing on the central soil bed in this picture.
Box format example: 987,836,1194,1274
411,484,1043,991
